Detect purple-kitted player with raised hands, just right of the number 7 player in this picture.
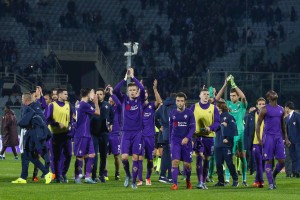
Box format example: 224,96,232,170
137,79,162,186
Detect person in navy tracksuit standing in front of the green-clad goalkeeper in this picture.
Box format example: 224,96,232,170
214,101,239,187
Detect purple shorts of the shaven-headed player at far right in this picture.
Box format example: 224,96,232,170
262,134,285,160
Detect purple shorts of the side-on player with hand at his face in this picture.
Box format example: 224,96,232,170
74,137,95,157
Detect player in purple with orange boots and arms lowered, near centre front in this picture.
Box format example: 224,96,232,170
169,92,196,190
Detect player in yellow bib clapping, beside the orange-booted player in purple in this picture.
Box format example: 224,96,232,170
191,88,220,189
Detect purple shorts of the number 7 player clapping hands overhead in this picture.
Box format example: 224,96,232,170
121,131,142,155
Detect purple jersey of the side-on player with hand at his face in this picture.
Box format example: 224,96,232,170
74,101,95,138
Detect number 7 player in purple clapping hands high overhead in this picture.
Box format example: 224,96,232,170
113,68,145,189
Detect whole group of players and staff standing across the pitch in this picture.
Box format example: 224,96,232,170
12,68,300,190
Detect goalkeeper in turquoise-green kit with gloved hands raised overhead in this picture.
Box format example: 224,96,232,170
216,75,248,186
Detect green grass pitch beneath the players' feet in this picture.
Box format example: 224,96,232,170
0,153,300,200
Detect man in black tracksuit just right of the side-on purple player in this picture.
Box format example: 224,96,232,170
91,88,113,183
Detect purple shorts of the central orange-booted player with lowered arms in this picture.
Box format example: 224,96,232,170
171,141,193,163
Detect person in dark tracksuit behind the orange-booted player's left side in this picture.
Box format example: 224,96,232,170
155,93,176,183
